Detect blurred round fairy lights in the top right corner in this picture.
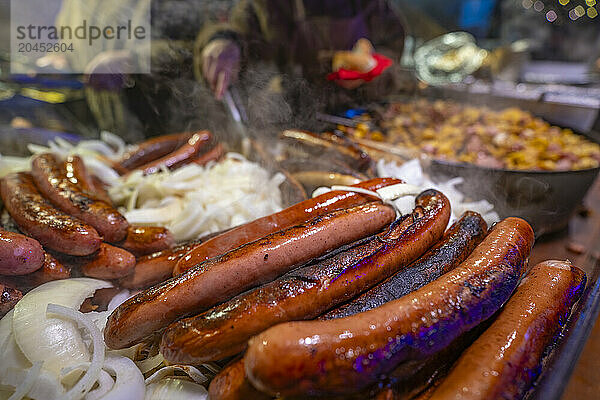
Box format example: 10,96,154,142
522,0,598,24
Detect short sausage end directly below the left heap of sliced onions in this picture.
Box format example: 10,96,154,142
118,226,175,257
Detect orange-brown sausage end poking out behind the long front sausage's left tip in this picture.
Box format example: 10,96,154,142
119,242,198,289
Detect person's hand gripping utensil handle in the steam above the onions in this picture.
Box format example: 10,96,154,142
201,39,241,100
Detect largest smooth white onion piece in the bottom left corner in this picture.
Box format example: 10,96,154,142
12,278,112,376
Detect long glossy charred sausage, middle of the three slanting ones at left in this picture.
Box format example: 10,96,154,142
31,153,128,242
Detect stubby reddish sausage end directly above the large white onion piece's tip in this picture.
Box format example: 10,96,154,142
81,243,135,279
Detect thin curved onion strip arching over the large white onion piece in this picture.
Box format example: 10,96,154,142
47,304,104,399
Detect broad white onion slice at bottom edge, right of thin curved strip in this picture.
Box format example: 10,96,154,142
102,356,146,400
